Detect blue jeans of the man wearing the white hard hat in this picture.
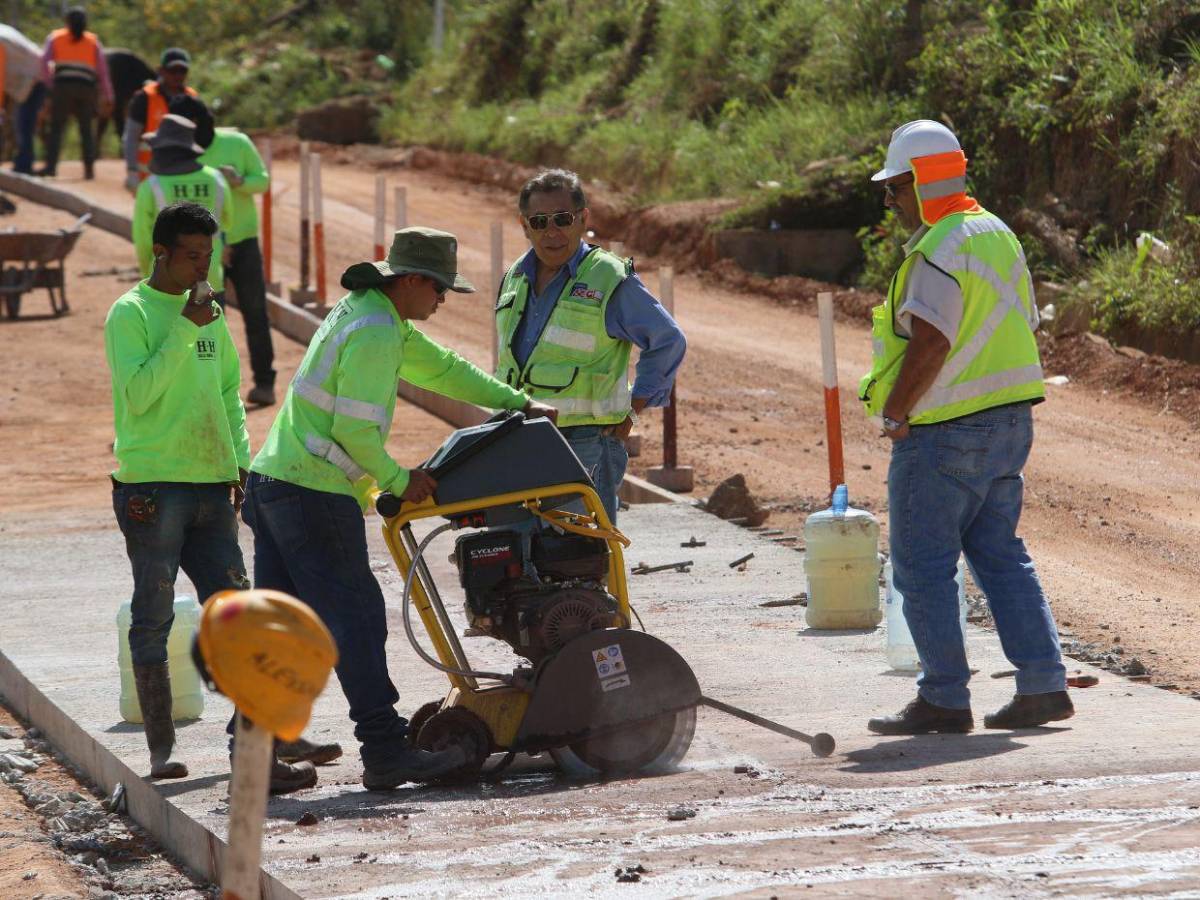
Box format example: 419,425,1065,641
888,403,1067,709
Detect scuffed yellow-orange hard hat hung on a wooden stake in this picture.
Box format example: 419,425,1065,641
197,590,337,740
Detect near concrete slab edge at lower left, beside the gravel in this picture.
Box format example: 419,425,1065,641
0,652,301,900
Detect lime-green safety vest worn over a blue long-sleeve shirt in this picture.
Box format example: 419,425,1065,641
496,247,632,427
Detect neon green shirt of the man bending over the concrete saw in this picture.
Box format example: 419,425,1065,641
251,288,529,510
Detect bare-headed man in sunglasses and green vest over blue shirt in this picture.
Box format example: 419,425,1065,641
496,169,686,522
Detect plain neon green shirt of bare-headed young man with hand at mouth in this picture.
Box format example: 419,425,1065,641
104,281,250,484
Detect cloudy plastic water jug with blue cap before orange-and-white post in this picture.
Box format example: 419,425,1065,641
804,485,883,629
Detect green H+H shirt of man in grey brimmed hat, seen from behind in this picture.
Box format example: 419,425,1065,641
133,166,233,290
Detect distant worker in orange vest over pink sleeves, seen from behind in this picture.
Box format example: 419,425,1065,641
37,6,113,179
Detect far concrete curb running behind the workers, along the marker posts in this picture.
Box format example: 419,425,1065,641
0,172,689,503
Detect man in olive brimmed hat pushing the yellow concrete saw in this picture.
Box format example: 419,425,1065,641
242,228,554,791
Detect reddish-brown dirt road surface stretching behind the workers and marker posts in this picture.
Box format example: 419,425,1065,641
9,161,1200,710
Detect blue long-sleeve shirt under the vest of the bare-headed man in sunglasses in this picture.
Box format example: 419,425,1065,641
512,241,688,407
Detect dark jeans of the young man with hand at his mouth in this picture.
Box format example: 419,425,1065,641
113,481,250,666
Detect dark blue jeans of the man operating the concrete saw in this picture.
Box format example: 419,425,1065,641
241,472,408,763
